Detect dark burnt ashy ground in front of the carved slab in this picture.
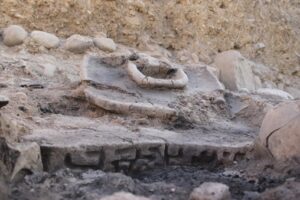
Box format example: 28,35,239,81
4,166,292,200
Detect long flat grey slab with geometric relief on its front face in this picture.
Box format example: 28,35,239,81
24,116,252,171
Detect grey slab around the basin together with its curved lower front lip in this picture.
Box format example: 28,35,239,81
81,56,223,117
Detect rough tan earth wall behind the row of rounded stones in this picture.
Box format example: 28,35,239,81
0,0,300,75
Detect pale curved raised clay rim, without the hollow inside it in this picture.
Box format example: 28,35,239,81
127,61,189,89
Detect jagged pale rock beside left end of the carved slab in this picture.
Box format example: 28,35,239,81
0,138,43,180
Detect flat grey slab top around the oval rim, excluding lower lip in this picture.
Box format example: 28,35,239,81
81,56,223,111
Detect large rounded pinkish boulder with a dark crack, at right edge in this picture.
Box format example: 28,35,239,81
258,100,300,160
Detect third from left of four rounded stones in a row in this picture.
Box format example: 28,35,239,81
64,34,94,53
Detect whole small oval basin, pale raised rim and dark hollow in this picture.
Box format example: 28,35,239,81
127,62,188,89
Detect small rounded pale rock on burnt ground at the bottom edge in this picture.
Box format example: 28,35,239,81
189,182,231,200
